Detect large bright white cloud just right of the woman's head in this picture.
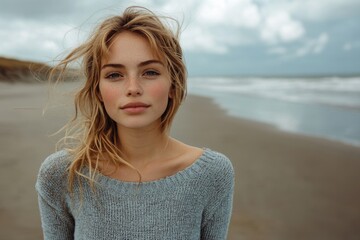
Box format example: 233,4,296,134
166,0,306,54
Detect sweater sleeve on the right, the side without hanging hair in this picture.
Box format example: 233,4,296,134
201,154,234,240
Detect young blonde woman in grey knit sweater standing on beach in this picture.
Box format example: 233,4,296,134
36,7,234,240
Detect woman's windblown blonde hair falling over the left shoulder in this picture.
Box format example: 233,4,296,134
53,7,187,192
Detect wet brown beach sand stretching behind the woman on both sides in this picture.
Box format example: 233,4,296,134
0,83,360,240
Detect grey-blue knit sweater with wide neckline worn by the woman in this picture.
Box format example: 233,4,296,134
36,149,234,240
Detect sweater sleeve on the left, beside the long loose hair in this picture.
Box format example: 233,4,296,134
35,153,74,240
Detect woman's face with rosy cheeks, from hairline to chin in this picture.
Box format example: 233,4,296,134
99,31,171,129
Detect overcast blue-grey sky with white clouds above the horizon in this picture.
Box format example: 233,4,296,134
0,0,360,76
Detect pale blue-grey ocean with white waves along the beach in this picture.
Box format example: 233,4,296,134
188,76,360,146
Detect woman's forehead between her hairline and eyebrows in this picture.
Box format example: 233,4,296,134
102,31,164,64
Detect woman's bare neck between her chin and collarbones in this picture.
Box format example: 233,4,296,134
118,124,170,166
